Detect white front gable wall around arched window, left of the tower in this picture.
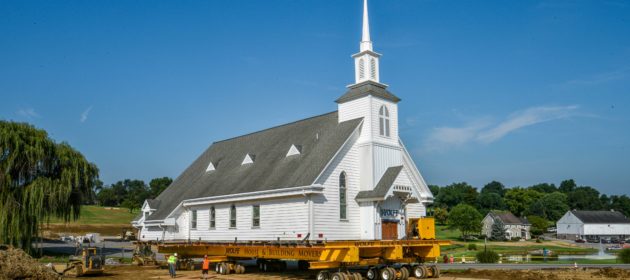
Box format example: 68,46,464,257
313,130,361,240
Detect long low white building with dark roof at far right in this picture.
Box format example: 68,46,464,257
556,210,630,240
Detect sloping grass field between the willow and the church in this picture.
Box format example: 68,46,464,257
50,205,139,225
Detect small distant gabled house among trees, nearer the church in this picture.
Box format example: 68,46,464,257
481,211,531,240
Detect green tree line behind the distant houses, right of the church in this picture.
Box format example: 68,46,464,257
429,179,630,238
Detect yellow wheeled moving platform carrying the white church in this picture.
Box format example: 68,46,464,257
157,218,451,280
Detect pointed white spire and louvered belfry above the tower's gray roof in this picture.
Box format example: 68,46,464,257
352,0,381,84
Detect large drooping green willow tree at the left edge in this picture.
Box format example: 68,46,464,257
0,120,98,252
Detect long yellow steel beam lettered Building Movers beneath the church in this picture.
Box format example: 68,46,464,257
157,239,451,269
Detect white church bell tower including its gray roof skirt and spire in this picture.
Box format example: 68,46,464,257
335,0,402,195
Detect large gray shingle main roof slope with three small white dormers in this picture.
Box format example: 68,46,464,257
147,111,362,220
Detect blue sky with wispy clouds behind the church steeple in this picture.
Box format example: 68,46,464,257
0,0,630,194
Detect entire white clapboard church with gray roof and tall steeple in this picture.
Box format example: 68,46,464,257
132,0,433,241
